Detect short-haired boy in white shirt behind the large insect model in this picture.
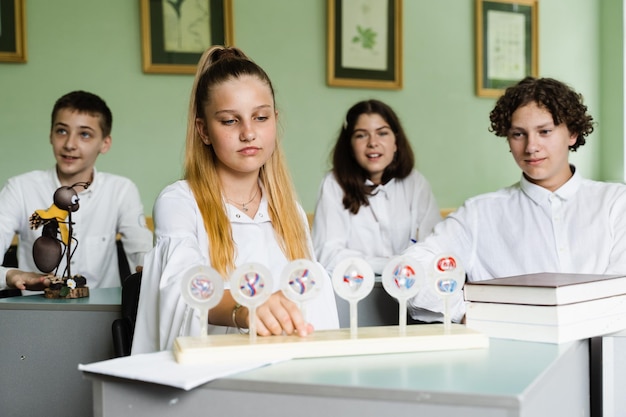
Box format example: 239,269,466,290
0,91,152,290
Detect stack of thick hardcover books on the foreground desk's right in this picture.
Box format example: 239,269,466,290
464,273,626,343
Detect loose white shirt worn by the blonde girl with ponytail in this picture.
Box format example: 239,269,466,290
132,181,339,354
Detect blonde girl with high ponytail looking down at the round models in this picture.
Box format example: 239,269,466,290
133,46,338,353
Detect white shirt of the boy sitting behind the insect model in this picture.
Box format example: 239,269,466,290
0,168,152,288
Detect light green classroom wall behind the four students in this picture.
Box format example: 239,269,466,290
0,0,623,214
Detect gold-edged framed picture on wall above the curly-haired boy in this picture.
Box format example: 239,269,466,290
476,0,539,97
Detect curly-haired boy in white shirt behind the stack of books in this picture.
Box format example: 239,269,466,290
405,77,626,322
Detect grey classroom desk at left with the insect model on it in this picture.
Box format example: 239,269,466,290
0,288,121,417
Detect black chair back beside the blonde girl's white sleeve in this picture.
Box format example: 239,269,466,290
111,272,141,358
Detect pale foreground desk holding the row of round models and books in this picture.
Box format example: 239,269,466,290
87,339,590,417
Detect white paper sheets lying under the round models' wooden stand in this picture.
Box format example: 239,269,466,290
78,351,281,391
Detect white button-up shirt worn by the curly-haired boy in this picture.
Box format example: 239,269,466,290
406,166,626,322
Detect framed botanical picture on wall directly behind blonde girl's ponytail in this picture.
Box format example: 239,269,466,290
140,0,234,74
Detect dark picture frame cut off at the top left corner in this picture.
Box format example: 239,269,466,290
0,0,27,63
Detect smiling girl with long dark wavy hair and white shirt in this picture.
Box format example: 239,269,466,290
313,100,441,274
